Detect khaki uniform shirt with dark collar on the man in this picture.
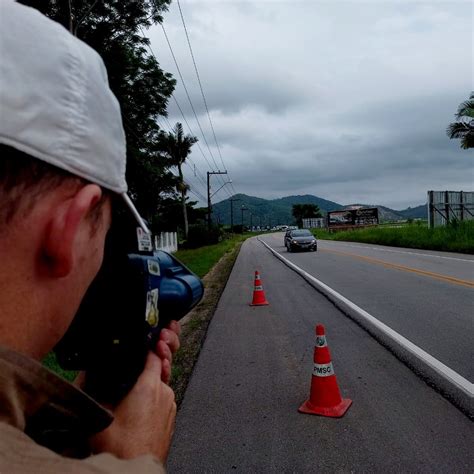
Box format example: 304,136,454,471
0,346,164,474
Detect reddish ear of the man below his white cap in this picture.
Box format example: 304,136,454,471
43,184,102,278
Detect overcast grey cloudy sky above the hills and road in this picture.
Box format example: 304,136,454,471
146,0,474,209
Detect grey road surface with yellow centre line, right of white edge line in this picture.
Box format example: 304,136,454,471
262,234,474,382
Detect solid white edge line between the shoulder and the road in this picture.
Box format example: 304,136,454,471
258,238,474,397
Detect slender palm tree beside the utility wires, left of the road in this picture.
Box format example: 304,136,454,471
164,122,198,239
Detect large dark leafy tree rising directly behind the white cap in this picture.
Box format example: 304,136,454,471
21,0,180,219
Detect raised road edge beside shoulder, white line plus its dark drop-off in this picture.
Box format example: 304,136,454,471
258,238,474,419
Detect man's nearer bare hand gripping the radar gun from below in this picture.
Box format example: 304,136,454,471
91,352,179,463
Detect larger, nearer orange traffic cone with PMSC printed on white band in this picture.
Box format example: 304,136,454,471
298,324,352,418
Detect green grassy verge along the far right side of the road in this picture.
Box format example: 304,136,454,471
312,221,474,254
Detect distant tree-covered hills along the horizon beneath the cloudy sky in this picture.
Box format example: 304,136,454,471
212,194,426,227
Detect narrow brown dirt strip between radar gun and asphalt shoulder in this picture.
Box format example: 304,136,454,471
170,243,242,408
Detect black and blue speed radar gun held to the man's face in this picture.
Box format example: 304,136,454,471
55,215,204,403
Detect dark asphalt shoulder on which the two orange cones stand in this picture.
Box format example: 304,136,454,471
168,235,474,473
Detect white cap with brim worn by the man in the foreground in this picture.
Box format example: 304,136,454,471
0,0,149,233
